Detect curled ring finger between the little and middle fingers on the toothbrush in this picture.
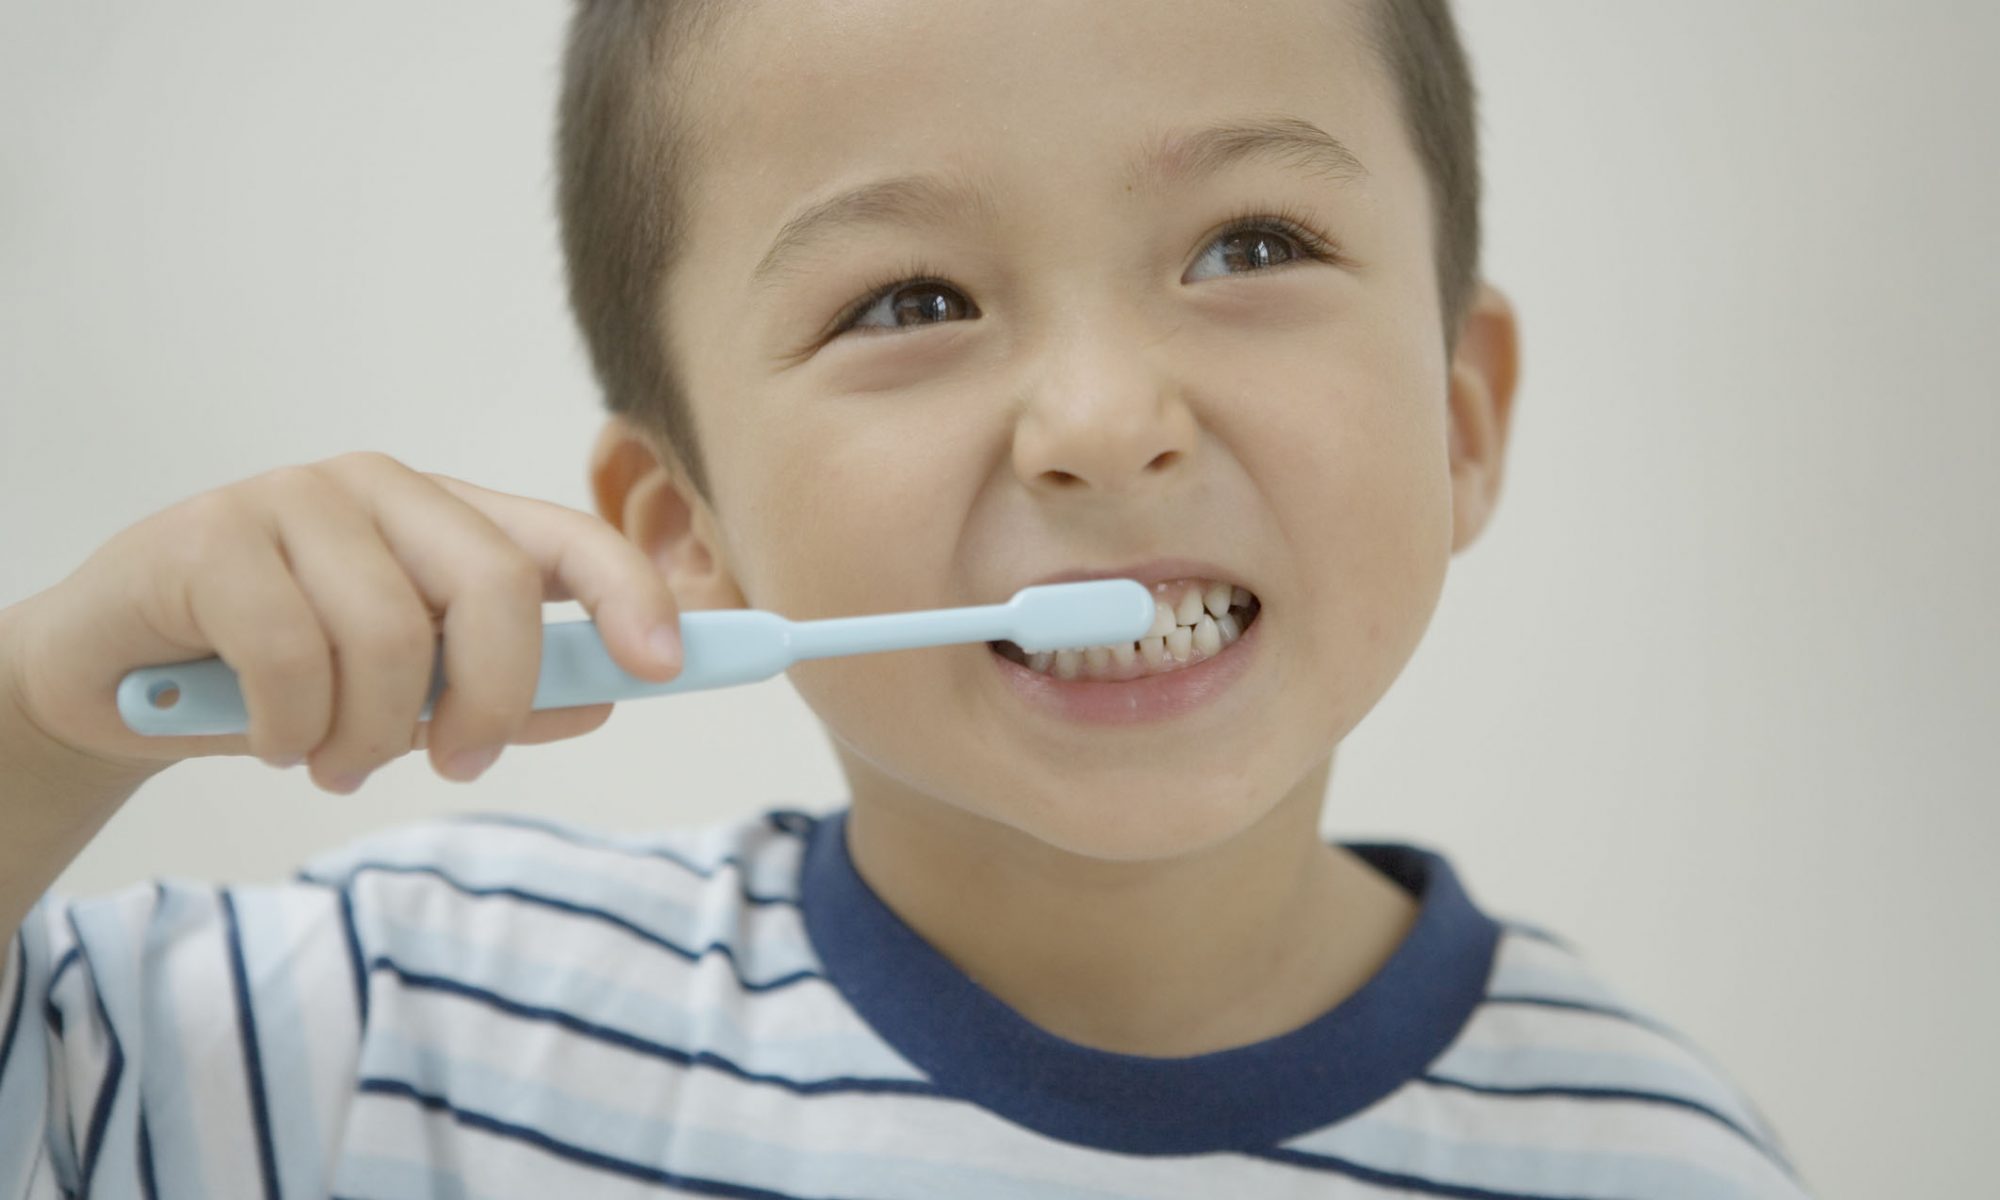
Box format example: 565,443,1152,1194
256,466,438,794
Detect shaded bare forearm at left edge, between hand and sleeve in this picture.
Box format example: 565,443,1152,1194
0,612,156,944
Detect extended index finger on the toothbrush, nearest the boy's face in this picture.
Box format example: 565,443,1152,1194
424,474,682,682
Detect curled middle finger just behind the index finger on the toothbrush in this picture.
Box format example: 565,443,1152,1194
326,454,542,780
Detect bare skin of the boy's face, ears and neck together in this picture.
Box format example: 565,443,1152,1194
590,0,1518,1056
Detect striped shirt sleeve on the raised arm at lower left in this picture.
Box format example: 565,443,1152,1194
0,880,366,1200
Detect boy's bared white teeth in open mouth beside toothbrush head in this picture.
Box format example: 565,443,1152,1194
988,578,1262,684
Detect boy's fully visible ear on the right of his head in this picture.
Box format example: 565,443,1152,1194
1448,282,1520,554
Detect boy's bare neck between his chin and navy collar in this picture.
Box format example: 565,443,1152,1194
840,748,1416,1058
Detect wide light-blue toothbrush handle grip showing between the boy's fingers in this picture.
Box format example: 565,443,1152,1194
118,608,792,736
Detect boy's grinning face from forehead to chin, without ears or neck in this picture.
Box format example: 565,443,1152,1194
624,0,1510,858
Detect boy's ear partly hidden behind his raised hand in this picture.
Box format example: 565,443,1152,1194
590,416,748,612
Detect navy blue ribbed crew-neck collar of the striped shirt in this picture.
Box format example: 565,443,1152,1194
800,808,1500,1154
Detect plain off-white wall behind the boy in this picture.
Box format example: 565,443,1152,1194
0,0,2000,1198
